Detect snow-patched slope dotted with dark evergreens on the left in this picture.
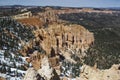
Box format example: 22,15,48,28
0,17,33,80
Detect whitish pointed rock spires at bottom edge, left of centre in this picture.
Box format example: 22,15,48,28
23,56,60,80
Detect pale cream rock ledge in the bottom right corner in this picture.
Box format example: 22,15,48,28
78,64,120,80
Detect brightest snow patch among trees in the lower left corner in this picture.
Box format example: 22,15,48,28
0,50,27,80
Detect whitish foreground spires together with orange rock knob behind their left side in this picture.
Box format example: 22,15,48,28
23,52,60,80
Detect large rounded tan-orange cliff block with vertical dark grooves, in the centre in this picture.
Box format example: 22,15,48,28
34,24,94,60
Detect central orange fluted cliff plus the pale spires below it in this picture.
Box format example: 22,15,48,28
22,23,94,80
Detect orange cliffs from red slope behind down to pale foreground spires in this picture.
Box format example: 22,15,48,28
14,10,94,80
